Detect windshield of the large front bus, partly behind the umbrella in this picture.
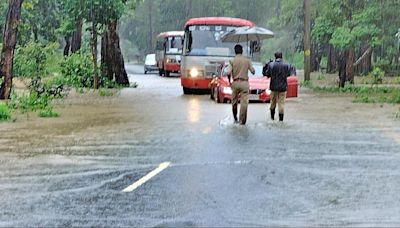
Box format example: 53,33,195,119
185,25,249,57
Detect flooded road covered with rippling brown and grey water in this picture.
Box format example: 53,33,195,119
0,65,400,227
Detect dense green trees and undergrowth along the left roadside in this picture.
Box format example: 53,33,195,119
0,0,137,121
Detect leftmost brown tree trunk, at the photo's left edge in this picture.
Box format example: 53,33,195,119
0,0,22,99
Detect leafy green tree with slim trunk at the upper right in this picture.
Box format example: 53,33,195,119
312,0,382,87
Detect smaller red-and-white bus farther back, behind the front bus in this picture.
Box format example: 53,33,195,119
156,31,184,77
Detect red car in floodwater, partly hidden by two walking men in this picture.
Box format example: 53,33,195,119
210,63,298,103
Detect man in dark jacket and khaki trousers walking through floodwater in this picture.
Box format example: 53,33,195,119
263,51,291,121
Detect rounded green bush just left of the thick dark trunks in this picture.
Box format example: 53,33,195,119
61,53,93,88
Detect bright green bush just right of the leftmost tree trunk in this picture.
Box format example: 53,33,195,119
14,41,58,78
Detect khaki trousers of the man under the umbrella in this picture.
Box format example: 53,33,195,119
231,81,249,124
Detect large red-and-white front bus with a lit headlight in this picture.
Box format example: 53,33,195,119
181,17,254,94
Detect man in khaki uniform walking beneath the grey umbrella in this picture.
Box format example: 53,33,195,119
228,44,255,125
